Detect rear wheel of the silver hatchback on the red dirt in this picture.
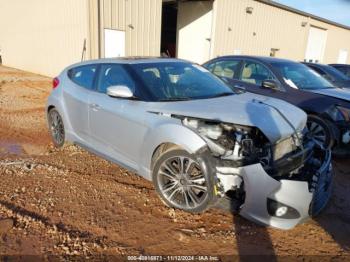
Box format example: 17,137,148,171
48,108,66,148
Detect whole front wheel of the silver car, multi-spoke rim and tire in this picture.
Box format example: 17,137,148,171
152,148,214,213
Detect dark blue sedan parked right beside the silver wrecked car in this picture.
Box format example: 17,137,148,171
204,56,350,155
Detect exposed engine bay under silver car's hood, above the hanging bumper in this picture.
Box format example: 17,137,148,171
183,118,308,174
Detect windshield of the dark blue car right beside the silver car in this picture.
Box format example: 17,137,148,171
271,62,334,89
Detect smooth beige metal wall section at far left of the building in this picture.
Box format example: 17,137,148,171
0,0,89,76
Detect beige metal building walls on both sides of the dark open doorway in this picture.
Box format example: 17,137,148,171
0,0,350,76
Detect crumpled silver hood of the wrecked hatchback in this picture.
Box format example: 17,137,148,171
148,93,307,143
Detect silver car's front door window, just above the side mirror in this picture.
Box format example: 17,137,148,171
97,64,135,93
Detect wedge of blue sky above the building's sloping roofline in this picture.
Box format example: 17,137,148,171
274,0,350,26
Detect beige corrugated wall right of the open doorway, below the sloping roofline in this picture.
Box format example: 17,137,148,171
211,0,350,63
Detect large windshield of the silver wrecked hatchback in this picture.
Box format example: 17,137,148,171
131,62,234,101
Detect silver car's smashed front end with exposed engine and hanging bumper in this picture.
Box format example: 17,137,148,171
181,117,332,229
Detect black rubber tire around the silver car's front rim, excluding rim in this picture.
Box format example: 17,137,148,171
152,149,215,213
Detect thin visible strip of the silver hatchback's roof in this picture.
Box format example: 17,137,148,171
69,56,190,68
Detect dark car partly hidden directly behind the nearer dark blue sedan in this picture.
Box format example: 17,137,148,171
303,63,350,88
